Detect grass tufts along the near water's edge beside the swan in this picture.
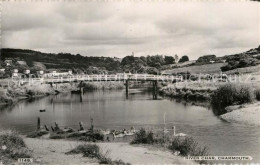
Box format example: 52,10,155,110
131,128,209,164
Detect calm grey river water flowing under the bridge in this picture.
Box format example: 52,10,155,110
0,90,260,162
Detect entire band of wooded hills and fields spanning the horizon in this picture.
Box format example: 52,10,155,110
0,46,260,74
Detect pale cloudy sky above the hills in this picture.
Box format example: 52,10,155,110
1,0,260,59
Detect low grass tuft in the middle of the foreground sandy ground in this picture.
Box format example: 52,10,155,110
66,144,128,165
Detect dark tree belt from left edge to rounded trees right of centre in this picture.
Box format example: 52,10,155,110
1,49,189,74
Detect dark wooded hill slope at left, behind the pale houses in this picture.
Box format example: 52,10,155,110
1,49,120,71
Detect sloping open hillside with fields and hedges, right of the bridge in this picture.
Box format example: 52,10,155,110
162,46,260,74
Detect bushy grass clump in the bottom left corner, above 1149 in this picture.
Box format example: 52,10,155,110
0,131,32,163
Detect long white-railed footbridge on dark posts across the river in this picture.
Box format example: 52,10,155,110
8,74,182,99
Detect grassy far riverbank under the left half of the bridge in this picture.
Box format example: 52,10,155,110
0,80,124,105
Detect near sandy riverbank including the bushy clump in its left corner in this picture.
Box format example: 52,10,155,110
0,131,195,165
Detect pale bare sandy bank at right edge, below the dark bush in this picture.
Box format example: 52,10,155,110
220,101,260,126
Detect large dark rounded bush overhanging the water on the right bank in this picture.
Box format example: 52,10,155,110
211,84,254,115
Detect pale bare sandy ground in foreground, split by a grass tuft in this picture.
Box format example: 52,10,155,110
24,138,194,165
